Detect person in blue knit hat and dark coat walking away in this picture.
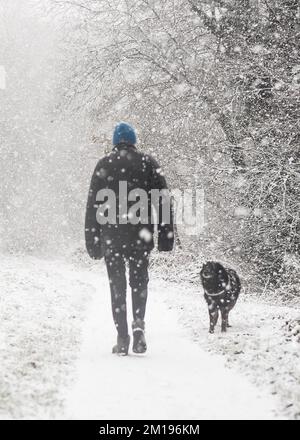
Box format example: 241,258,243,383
85,123,174,356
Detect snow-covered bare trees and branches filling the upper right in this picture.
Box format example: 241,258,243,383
54,0,300,288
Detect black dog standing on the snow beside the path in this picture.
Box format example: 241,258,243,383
200,262,241,333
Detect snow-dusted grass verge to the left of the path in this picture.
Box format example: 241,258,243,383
0,256,90,419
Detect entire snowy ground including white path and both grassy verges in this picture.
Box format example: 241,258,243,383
0,258,300,419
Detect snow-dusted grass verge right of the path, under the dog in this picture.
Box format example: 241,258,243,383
157,281,300,420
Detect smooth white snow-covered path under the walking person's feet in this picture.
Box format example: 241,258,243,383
65,275,275,420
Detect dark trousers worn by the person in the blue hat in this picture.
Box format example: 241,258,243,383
105,250,149,338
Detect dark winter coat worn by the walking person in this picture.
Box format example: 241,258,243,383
85,144,174,260
